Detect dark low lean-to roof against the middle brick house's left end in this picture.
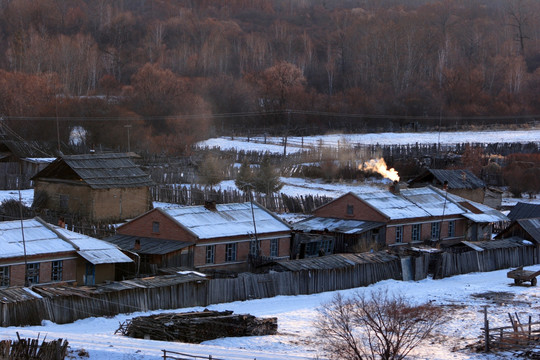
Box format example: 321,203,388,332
104,234,193,255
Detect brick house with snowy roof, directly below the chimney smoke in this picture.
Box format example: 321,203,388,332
314,186,506,246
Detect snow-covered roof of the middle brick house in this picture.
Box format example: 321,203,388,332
159,202,291,239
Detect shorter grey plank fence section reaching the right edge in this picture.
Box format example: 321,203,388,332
434,246,540,278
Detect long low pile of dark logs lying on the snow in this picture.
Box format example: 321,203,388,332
116,309,277,343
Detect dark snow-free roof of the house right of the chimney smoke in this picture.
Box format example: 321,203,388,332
410,169,486,189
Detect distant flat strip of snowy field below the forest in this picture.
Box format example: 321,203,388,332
198,129,540,154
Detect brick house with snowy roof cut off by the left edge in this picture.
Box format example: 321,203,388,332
0,217,131,287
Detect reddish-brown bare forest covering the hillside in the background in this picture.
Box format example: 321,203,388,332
0,0,540,153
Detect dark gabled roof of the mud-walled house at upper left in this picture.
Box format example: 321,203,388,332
33,153,153,189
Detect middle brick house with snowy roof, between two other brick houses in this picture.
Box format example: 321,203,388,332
117,202,291,271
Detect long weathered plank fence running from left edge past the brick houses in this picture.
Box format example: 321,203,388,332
0,259,401,326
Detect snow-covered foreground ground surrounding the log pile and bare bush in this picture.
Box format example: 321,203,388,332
0,265,540,360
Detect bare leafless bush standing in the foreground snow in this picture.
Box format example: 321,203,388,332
315,290,444,360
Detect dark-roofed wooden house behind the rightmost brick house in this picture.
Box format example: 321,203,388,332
409,169,502,208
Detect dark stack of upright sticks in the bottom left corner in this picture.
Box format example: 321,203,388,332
0,333,68,360
